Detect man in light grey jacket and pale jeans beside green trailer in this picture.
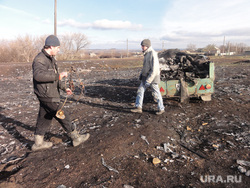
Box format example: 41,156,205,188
131,39,165,115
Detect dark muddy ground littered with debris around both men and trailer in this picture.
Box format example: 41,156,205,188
0,58,250,188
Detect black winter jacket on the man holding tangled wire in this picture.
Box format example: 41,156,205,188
32,49,66,102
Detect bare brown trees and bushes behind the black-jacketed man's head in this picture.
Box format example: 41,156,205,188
0,33,90,62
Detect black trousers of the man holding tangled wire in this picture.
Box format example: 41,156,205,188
35,101,74,135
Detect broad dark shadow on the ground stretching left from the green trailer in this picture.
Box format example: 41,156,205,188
68,79,158,113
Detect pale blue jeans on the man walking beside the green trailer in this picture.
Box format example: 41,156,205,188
135,82,165,110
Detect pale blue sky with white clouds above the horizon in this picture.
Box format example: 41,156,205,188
0,0,250,49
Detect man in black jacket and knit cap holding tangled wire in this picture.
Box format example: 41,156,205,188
32,35,90,151
